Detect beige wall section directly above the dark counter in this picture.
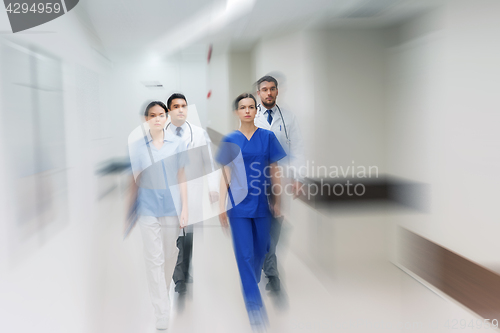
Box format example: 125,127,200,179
314,29,386,173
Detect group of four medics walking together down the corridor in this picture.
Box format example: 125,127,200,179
129,76,303,331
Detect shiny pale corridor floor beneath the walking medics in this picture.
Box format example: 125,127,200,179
87,193,487,333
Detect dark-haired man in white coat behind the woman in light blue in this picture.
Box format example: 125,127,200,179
166,93,219,294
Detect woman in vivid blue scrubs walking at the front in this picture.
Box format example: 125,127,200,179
217,94,286,330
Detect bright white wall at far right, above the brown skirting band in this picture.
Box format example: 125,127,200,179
388,0,500,265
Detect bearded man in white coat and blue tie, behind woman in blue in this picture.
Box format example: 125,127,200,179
254,75,305,292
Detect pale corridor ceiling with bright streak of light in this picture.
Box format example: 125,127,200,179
77,0,436,62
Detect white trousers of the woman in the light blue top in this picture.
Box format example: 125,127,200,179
138,216,180,318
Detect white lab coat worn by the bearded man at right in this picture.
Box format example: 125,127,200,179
254,104,307,182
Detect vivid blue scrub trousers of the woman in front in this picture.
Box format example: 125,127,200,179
229,217,271,311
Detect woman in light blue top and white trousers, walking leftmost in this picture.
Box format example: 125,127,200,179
129,101,188,330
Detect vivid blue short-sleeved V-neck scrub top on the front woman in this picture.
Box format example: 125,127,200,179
217,128,286,218
